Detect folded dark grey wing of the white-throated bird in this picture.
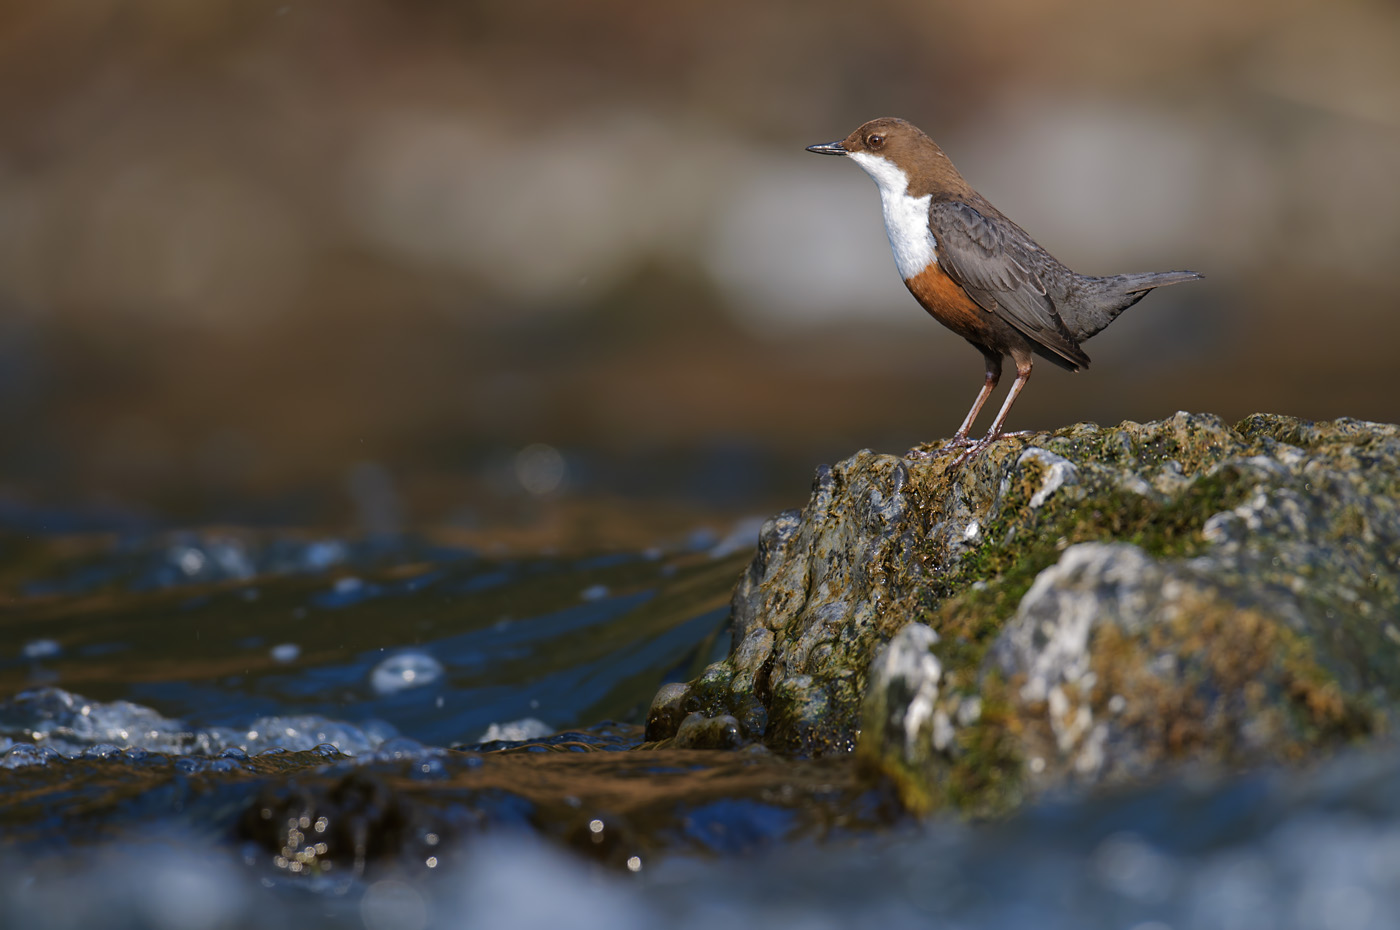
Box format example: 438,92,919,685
928,200,1089,367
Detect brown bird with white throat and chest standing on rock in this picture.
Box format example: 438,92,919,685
806,118,1204,461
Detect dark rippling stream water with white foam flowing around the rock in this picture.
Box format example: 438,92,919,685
0,527,1400,930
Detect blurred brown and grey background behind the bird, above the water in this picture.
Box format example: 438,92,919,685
0,0,1400,539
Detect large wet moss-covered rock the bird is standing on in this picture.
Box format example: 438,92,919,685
647,413,1400,812
